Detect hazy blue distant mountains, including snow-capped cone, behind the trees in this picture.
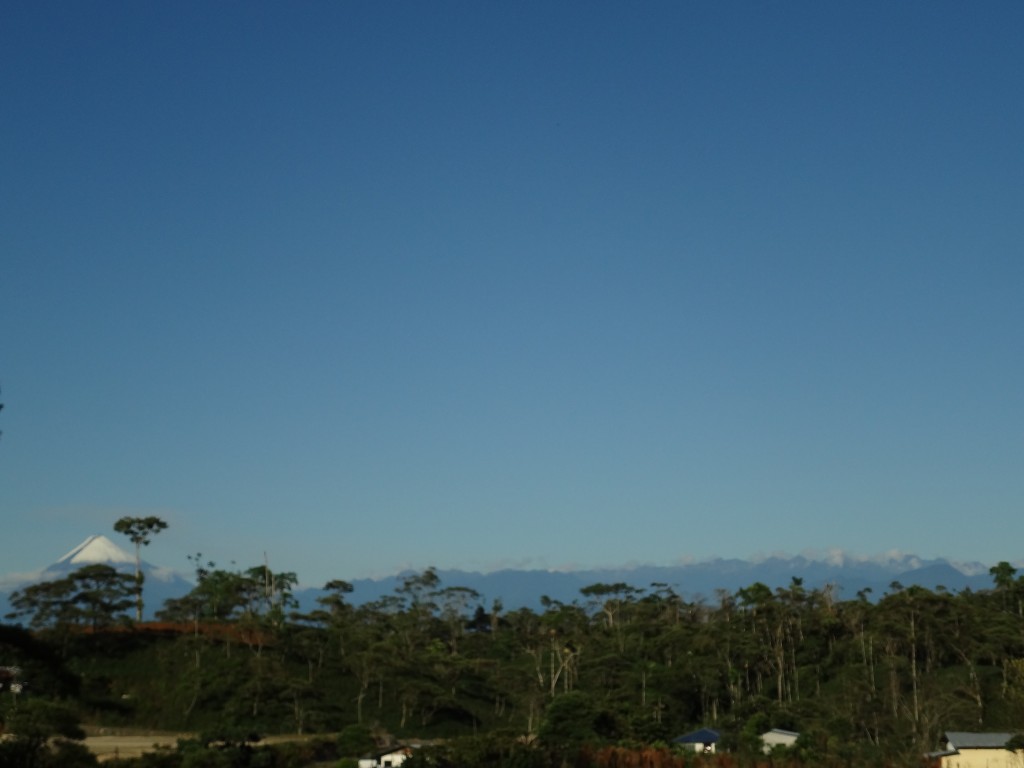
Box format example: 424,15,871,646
0,536,1007,617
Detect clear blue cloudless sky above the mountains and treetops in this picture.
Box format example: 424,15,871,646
0,0,1024,585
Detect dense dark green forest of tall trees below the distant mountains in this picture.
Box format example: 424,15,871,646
0,532,1024,765
